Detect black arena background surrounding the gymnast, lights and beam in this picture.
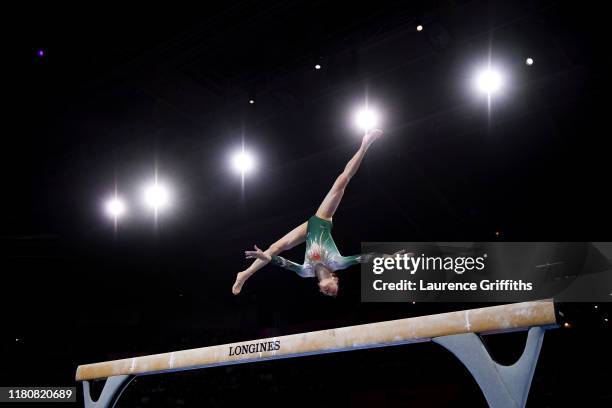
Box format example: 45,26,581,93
0,1,612,407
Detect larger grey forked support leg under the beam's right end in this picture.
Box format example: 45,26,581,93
432,327,544,408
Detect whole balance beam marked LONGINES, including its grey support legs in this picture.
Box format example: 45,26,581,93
76,300,557,408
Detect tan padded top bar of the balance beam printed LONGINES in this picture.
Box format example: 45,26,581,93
76,301,556,381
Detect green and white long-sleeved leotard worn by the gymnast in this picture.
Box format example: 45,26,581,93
270,215,371,278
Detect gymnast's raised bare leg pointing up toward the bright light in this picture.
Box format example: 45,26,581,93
316,129,383,221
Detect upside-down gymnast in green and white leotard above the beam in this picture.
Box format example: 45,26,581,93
232,129,394,297
